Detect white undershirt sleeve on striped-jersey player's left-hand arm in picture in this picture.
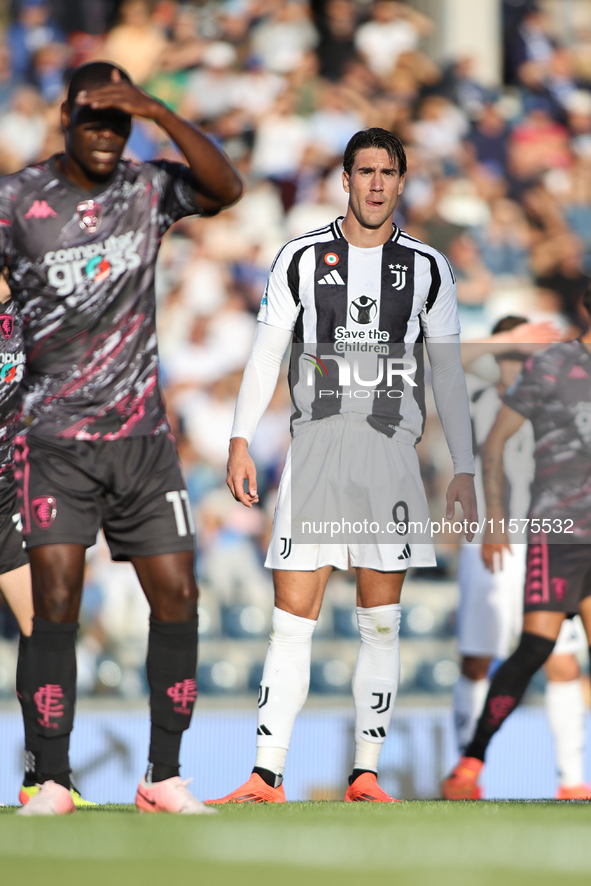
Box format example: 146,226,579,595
230,320,292,445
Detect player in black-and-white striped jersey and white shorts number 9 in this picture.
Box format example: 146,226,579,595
209,128,476,803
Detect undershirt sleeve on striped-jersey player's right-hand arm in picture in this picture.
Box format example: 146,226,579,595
425,335,475,474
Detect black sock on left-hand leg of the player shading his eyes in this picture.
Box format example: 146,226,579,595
24,616,78,787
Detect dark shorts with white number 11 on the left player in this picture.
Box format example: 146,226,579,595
16,434,195,560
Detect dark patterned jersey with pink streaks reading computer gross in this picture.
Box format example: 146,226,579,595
0,157,199,440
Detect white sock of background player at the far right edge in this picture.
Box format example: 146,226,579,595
546,680,585,787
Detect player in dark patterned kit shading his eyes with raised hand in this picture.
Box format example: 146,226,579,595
0,62,242,815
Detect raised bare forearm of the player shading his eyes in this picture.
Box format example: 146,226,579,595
153,103,243,212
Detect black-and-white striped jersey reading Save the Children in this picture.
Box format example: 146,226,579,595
258,218,460,445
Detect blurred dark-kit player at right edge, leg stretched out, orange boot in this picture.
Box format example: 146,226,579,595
443,292,591,800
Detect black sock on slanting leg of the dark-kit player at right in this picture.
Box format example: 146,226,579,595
464,632,555,760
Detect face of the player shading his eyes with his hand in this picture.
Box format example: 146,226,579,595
62,104,131,182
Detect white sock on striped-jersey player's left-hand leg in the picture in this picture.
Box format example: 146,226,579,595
255,608,316,786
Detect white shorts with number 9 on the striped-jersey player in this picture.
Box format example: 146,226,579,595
265,413,437,572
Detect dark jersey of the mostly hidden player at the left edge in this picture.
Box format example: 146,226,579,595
0,299,25,509
